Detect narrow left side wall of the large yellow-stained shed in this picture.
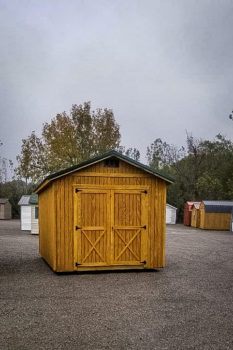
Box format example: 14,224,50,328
38,184,56,270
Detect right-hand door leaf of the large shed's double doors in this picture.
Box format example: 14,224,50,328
111,190,148,265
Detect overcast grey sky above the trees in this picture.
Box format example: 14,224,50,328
0,0,233,165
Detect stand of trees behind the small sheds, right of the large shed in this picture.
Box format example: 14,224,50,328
147,134,233,219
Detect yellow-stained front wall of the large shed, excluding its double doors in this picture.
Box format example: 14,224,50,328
52,161,166,271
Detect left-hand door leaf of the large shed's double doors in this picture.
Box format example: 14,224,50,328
74,189,110,266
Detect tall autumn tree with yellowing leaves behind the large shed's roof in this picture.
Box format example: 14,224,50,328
16,102,123,182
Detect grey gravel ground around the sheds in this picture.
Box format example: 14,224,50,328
0,220,233,350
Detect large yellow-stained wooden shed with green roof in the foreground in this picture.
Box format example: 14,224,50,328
35,151,173,272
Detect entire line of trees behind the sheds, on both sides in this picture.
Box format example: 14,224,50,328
0,102,233,219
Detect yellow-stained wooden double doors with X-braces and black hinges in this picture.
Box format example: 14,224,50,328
74,187,148,269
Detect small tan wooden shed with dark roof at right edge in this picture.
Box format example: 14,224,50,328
200,201,233,231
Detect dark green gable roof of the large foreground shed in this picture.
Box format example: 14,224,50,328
34,151,174,193
